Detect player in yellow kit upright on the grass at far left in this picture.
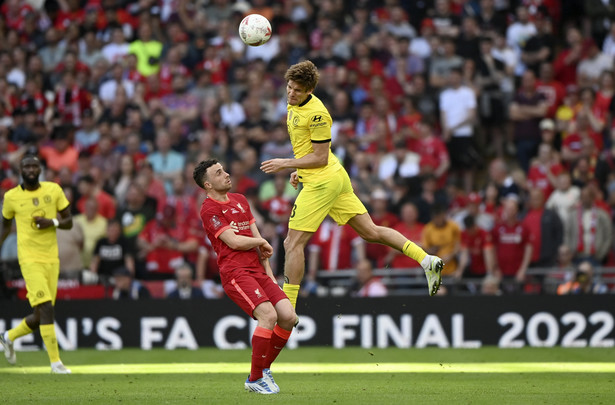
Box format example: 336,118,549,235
0,156,73,374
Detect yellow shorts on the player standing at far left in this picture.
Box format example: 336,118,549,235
20,263,60,307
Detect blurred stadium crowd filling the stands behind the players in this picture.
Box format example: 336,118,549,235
0,0,615,298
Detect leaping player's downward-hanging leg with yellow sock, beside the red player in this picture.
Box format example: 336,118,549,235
282,229,314,307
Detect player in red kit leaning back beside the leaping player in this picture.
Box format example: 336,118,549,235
193,159,296,394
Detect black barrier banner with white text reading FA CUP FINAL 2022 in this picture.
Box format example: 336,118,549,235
0,295,615,350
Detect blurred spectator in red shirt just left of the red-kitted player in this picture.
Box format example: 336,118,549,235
138,205,199,280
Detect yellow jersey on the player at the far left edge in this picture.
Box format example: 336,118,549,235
2,181,69,264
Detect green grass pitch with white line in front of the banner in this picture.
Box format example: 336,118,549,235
0,347,615,405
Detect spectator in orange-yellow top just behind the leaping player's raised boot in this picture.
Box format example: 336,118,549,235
421,204,461,276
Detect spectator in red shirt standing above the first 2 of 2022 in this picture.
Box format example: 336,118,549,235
492,197,532,293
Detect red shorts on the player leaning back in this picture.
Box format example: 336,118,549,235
222,271,288,317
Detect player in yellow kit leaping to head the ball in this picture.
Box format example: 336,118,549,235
261,61,443,306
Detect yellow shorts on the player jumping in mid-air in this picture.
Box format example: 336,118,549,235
288,169,367,232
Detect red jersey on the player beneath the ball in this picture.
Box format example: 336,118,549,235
201,193,266,281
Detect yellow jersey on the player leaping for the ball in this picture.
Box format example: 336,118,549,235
286,94,342,183
